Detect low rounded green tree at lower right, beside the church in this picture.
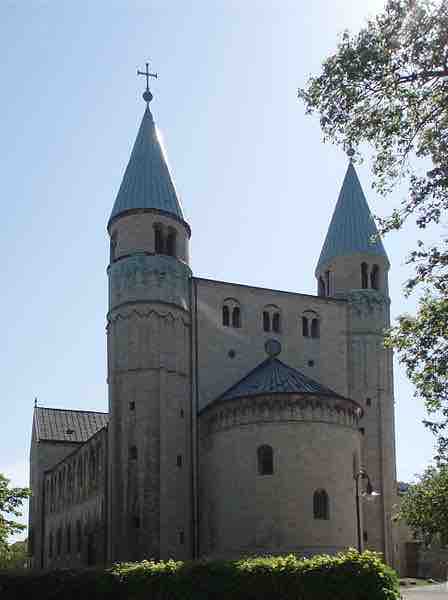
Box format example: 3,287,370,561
396,465,448,541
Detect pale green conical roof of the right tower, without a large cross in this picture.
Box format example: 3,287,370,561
316,161,388,273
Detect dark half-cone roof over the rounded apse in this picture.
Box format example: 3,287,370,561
217,357,342,401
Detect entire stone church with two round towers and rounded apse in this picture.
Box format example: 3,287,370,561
29,68,398,568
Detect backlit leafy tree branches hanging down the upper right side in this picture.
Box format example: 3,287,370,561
298,0,448,459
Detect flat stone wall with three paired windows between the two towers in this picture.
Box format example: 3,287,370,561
193,278,348,408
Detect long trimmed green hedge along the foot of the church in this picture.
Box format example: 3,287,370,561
0,550,400,600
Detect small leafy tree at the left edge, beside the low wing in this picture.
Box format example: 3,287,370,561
0,473,30,559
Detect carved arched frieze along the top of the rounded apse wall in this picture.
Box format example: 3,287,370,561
200,394,363,438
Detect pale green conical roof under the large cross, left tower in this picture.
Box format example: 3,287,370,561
109,107,184,222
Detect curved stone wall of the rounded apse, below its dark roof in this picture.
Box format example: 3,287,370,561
199,394,360,558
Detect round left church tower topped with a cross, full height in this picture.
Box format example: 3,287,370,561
107,70,192,561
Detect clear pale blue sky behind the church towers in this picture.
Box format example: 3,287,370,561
0,0,433,536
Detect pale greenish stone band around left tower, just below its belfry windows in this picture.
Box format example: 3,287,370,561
108,253,191,310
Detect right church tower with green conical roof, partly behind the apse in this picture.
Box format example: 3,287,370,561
315,151,396,564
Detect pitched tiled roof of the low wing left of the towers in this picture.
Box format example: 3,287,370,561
34,406,109,442
